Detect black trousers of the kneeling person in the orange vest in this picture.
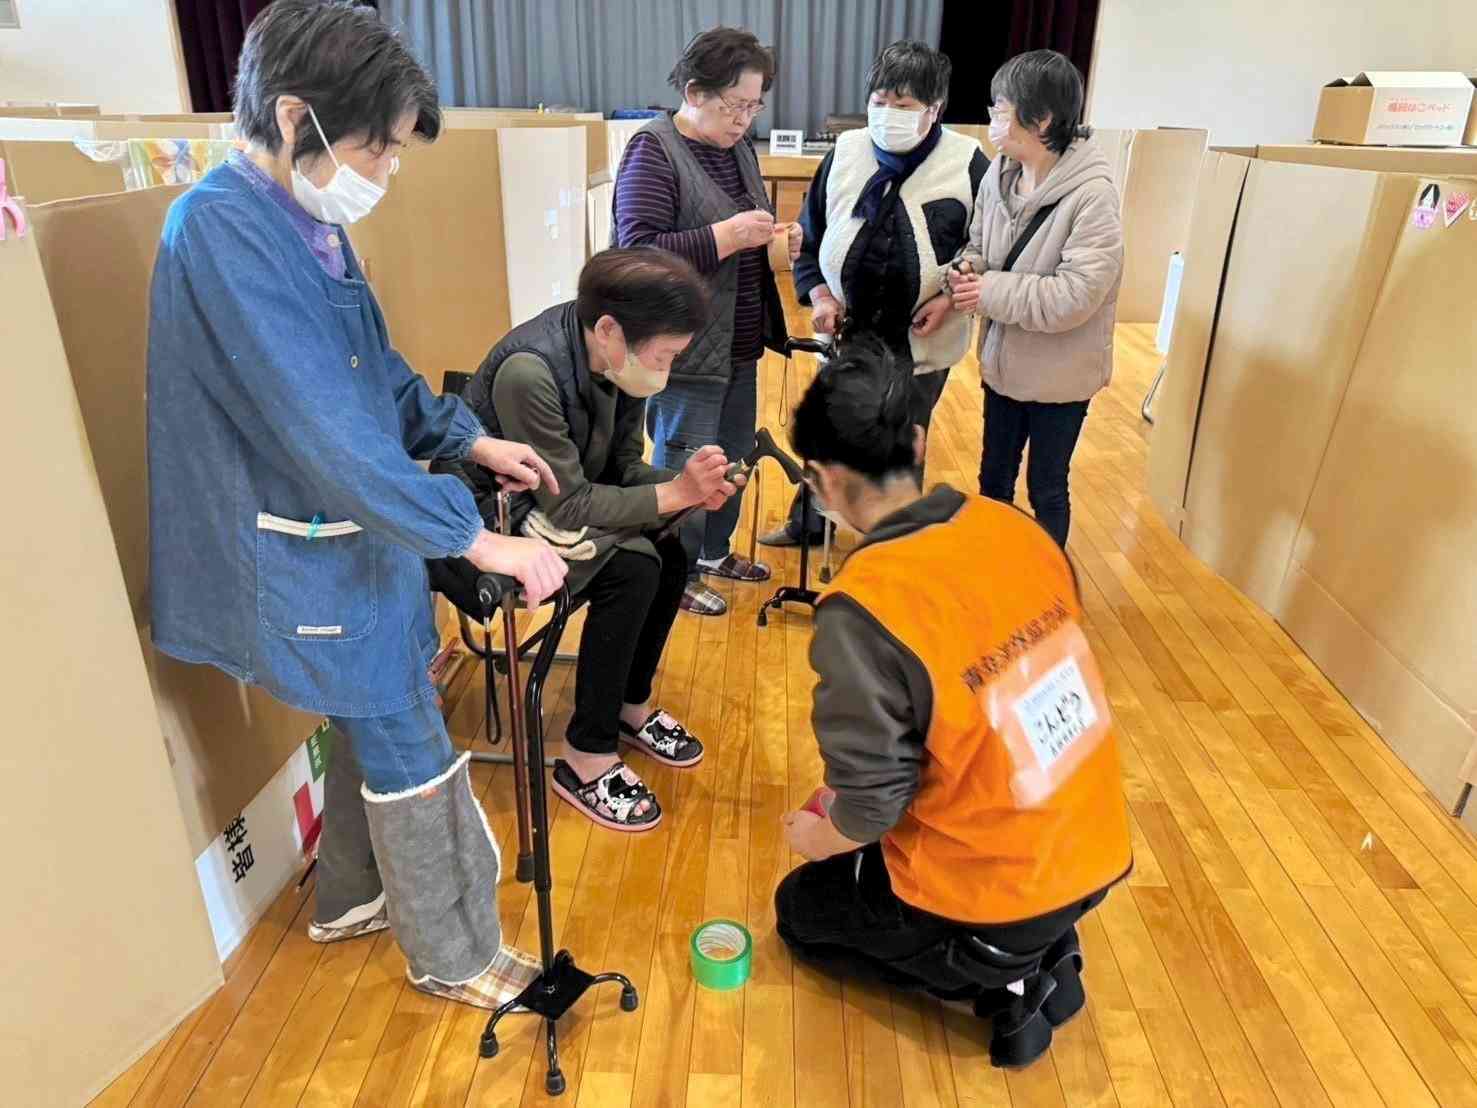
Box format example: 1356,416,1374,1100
774,844,1108,993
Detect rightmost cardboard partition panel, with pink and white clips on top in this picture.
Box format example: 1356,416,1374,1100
1273,179,1477,829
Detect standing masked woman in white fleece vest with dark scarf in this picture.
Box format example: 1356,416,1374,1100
759,41,990,547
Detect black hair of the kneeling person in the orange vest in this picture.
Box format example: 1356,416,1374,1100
790,338,916,485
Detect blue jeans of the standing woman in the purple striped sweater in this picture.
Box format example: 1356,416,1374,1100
647,362,759,573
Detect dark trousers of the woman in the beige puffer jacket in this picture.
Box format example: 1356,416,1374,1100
979,386,1087,550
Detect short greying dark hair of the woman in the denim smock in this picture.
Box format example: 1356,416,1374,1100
236,0,442,163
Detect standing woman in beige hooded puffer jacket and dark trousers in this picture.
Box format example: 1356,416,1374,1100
951,50,1123,547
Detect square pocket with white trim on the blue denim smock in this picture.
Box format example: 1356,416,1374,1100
257,513,380,643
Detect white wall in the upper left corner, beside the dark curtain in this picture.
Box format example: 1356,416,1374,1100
0,0,191,112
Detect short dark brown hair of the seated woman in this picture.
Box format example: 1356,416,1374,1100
575,247,709,346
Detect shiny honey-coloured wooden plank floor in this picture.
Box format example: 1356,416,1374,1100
97,291,1477,1108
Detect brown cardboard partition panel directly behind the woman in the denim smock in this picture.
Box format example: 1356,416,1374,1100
31,188,319,858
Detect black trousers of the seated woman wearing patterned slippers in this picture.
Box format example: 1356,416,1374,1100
564,535,687,753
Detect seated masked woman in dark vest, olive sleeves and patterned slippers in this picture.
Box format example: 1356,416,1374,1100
464,248,736,832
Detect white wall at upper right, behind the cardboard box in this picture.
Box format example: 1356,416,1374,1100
1087,0,1477,146
